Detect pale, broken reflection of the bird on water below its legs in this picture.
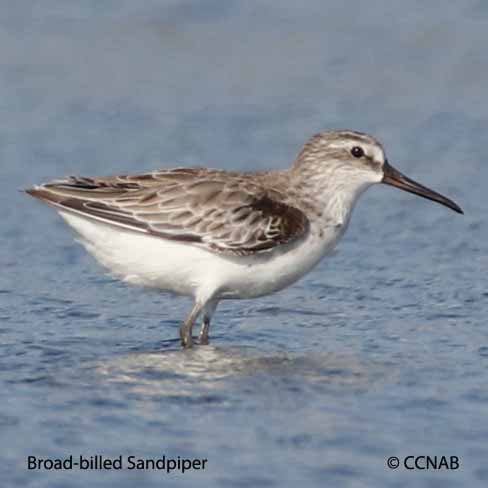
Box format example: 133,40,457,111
96,341,387,398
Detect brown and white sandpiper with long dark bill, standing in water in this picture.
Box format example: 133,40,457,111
25,130,463,348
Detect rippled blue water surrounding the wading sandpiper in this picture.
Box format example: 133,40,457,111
0,0,488,488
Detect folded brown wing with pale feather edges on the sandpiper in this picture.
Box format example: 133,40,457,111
27,168,309,256
